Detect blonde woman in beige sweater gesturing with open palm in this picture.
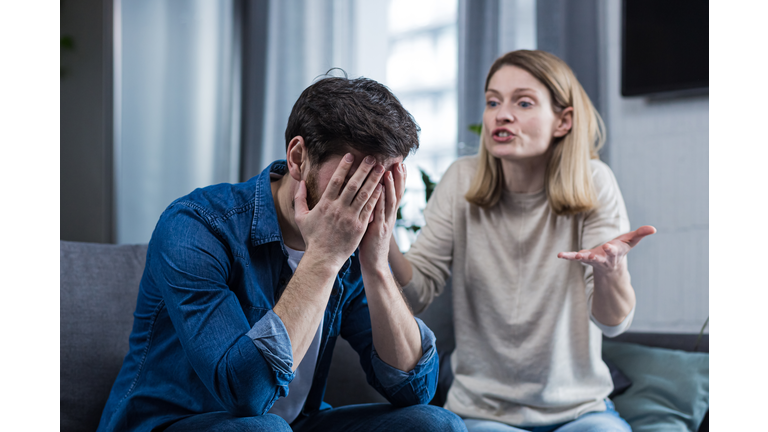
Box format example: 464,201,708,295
389,50,655,431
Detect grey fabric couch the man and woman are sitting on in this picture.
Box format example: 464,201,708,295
60,241,709,432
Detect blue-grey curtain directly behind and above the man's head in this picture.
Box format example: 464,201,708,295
240,0,387,180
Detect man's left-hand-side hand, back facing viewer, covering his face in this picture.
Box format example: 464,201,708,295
294,154,384,268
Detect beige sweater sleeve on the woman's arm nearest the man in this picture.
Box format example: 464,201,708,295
403,162,459,314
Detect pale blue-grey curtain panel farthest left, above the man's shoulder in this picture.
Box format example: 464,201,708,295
115,0,241,243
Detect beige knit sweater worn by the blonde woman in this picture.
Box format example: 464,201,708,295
403,156,629,426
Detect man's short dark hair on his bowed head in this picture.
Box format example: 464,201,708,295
285,73,421,165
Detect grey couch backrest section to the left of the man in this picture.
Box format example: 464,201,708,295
59,241,147,431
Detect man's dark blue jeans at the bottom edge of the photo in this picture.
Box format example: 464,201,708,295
166,404,467,432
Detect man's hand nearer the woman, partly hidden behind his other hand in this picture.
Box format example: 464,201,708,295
360,163,406,271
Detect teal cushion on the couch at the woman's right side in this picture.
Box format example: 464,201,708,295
603,341,709,432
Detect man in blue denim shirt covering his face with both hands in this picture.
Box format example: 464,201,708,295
99,78,464,431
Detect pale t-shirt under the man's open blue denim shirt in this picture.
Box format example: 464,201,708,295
269,246,323,424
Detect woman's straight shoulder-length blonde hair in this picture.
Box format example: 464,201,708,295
464,50,605,215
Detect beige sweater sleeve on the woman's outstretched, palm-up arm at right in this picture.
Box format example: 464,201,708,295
581,160,634,337
